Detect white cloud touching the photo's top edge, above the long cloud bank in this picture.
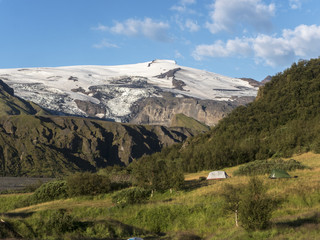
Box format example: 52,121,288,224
206,0,275,33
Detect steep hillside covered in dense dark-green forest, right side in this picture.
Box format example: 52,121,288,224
145,58,320,171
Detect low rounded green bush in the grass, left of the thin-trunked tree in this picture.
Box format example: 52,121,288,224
112,188,151,205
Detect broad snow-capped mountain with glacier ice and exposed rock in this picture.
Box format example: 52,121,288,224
0,60,258,125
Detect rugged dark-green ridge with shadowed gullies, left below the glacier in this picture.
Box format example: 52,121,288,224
0,78,194,177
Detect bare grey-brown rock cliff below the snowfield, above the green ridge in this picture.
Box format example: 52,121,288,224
130,94,254,126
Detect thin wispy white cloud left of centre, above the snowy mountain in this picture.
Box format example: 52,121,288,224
106,18,170,42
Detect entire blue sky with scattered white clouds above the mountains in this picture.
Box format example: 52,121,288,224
0,0,320,81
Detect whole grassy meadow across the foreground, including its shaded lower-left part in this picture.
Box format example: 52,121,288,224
0,153,320,240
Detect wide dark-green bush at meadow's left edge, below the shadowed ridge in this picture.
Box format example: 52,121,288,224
66,172,111,197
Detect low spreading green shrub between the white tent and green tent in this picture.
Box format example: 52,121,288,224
234,159,307,176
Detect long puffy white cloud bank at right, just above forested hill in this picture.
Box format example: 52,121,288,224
192,25,320,66
